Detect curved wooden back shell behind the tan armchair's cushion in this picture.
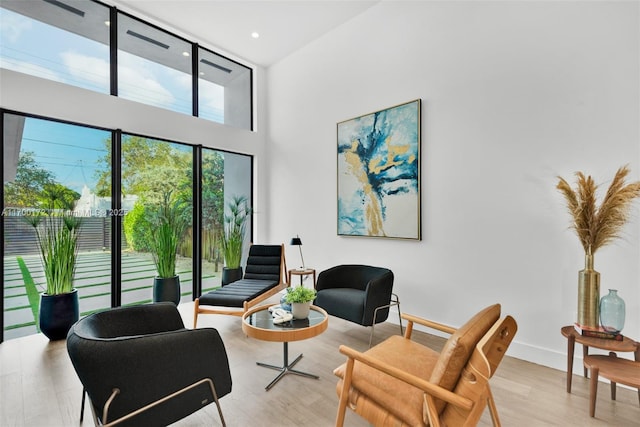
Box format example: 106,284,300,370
440,316,518,426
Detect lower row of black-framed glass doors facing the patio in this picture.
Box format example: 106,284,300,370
2,112,253,339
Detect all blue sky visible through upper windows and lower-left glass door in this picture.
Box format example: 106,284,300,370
0,8,229,192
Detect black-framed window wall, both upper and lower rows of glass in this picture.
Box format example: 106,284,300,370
0,0,253,341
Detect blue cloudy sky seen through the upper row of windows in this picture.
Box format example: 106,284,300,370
0,8,224,118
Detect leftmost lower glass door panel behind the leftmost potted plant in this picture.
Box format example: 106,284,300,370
2,114,111,339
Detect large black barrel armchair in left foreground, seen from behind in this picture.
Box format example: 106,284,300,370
67,302,231,426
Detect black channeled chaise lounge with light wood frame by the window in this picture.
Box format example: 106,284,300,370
193,244,287,328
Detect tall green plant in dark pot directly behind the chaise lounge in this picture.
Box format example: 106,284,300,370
221,196,252,286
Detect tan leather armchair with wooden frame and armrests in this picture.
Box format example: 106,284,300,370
334,304,517,427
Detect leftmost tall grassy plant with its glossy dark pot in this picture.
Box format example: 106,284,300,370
25,209,82,340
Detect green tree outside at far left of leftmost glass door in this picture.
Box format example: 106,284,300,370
4,151,54,208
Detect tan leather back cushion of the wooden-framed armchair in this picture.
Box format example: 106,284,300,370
429,304,500,416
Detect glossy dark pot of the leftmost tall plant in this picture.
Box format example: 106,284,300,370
38,289,80,341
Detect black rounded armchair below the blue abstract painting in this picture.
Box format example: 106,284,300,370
314,264,403,347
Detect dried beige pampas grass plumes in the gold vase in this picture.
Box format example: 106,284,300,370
556,166,640,254
